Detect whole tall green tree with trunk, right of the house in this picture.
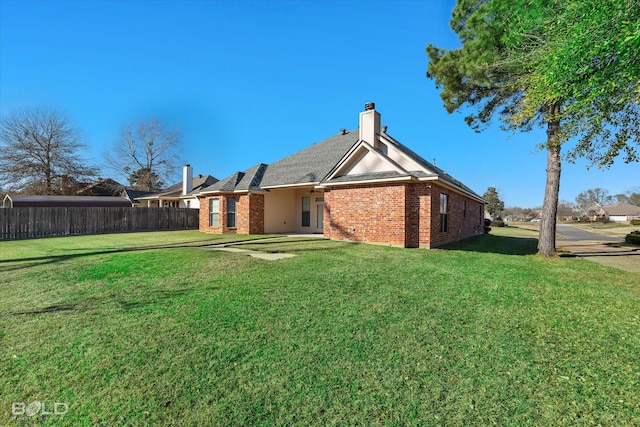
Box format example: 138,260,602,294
427,0,640,255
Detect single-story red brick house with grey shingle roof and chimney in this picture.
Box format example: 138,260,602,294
198,103,485,248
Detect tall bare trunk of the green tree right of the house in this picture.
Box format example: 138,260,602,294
538,104,561,257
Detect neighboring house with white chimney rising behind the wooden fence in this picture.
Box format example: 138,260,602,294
134,165,218,209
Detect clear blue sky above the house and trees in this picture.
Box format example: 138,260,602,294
0,0,640,207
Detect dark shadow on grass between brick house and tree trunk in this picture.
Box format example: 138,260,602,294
439,234,538,255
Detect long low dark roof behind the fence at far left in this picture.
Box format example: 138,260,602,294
2,194,131,208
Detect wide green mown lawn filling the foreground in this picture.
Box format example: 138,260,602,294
0,232,640,426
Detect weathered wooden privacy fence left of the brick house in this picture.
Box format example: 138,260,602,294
0,207,199,240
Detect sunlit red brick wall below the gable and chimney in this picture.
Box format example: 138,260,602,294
324,184,406,247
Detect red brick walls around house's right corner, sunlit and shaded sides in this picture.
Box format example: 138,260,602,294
324,183,483,248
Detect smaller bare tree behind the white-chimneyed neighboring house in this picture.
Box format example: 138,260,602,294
105,118,182,191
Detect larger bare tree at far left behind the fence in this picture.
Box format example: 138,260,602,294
0,108,96,195
